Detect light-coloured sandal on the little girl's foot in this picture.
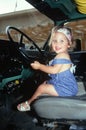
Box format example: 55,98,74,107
17,101,30,112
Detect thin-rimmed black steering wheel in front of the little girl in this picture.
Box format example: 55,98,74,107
6,26,43,61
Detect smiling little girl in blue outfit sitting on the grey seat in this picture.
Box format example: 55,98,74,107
17,26,78,111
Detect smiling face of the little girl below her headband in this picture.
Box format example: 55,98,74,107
51,32,70,53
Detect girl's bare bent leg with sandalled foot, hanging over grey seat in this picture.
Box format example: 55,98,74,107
17,83,58,111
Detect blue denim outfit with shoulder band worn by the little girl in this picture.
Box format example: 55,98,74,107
47,59,78,96
